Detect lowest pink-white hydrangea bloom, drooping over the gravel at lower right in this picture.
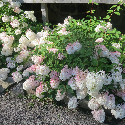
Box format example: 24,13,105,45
91,109,105,123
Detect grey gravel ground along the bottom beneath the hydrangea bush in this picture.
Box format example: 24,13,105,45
0,89,125,125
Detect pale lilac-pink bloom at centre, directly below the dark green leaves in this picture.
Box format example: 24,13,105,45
59,65,72,81
